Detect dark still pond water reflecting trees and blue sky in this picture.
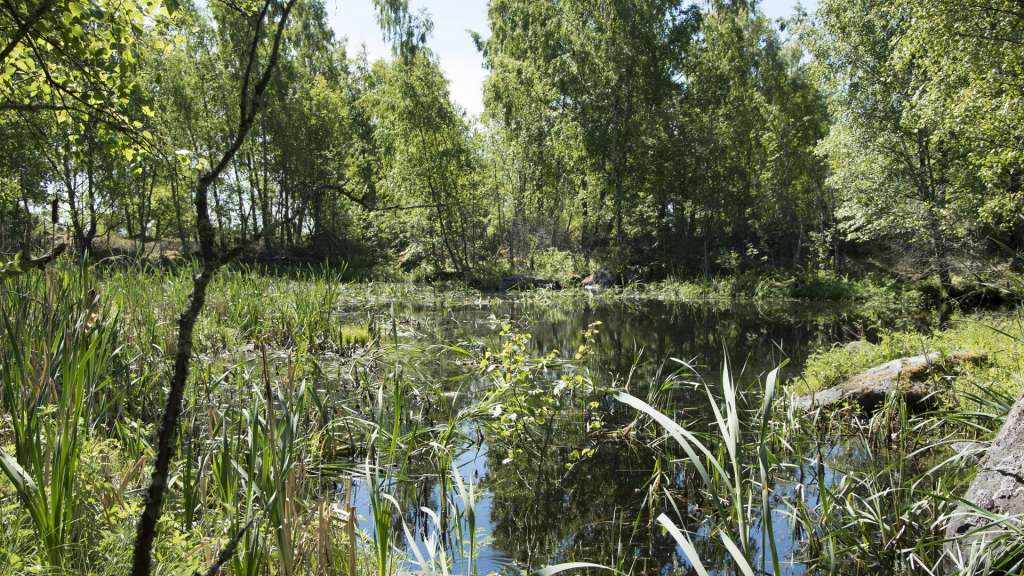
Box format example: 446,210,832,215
335,298,862,574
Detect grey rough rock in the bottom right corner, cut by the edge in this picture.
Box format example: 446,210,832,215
945,398,1024,568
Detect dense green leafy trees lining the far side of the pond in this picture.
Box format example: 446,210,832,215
0,0,1024,285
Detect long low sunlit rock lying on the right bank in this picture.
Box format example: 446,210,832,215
794,351,985,413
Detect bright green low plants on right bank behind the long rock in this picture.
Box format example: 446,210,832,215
792,311,1024,395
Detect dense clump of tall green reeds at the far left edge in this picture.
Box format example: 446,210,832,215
0,273,118,569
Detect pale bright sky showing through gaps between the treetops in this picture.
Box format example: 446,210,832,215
325,0,817,116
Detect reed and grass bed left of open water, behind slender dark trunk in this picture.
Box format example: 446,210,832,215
0,263,446,576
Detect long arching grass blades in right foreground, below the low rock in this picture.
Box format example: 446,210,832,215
615,340,1024,576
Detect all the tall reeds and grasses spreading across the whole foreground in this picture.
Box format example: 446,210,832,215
0,264,1022,576
